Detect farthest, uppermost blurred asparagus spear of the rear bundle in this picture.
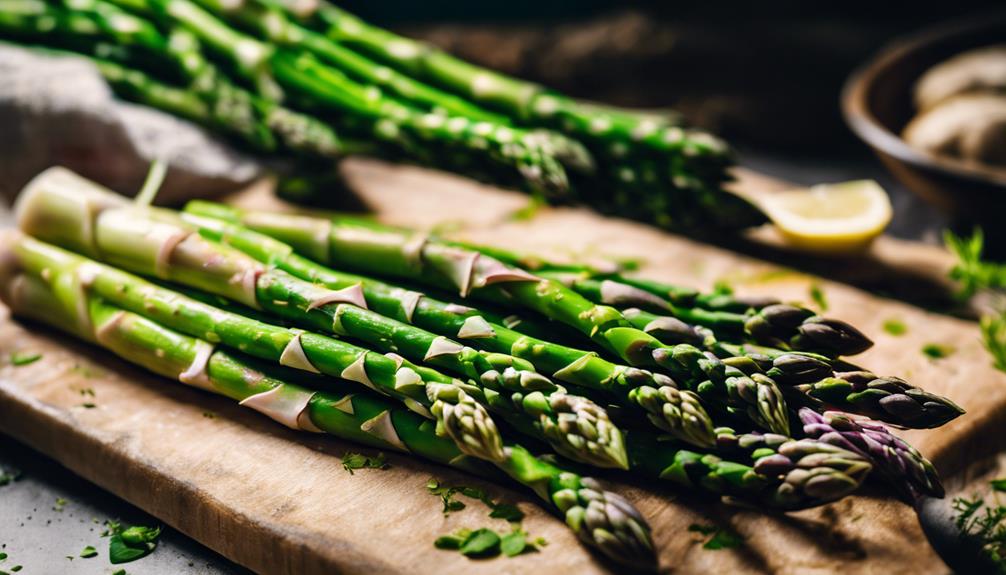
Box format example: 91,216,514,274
267,0,765,229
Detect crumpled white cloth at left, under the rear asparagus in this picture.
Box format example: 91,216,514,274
0,44,261,204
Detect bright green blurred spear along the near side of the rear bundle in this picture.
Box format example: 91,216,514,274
102,0,568,196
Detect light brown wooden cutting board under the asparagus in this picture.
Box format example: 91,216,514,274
0,160,1006,575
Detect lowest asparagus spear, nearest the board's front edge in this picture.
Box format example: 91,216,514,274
0,265,656,568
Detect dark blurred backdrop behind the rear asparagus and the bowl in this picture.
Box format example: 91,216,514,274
325,0,1002,242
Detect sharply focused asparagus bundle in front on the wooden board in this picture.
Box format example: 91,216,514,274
0,169,962,566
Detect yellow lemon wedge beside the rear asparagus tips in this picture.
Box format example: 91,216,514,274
759,180,892,253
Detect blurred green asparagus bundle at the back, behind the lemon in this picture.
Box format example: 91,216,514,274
0,0,765,234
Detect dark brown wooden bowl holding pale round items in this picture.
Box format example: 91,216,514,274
842,12,1006,223
